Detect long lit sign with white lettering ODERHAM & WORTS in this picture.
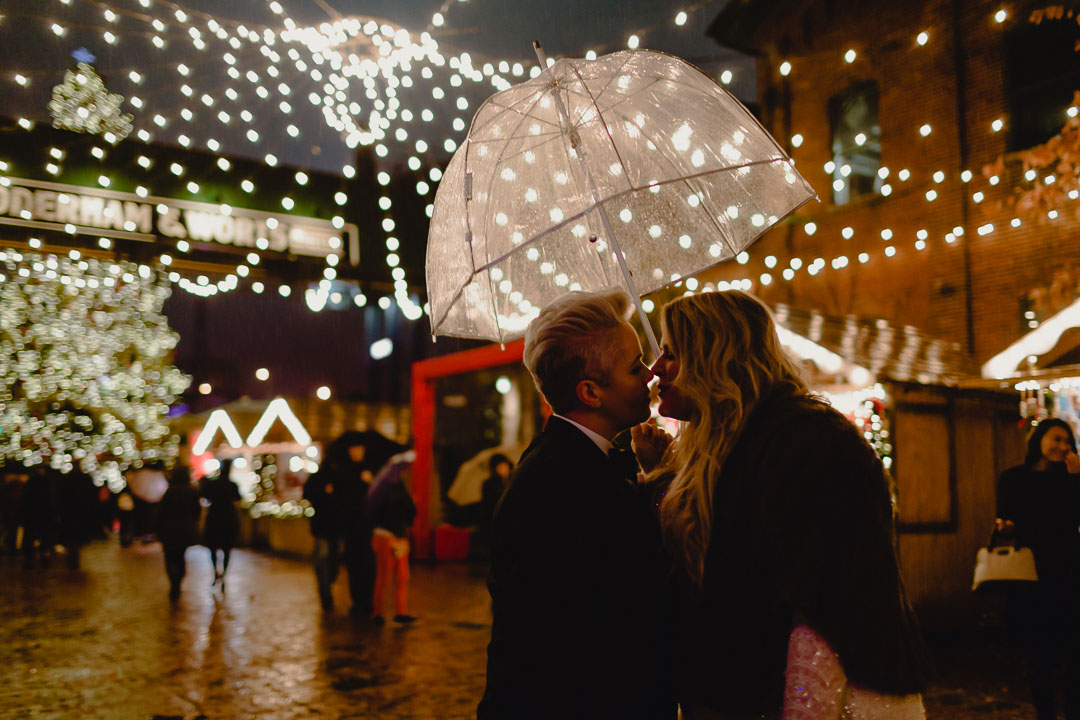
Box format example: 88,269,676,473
0,177,356,257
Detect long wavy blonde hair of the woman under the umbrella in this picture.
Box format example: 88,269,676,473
653,290,808,584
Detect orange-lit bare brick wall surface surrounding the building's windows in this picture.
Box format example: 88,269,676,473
701,0,1080,363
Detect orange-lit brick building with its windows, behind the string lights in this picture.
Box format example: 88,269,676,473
707,0,1080,364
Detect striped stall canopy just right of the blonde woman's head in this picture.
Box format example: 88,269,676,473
773,303,978,385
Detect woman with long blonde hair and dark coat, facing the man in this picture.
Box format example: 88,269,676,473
635,290,926,720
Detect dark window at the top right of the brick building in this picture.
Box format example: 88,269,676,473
1005,17,1080,151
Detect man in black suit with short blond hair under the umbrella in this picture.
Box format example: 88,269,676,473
477,290,676,720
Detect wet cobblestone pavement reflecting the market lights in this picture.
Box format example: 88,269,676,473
0,541,1034,720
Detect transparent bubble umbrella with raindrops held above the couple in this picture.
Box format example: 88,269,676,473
427,44,815,352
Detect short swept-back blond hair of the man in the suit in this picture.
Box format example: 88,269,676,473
523,289,630,415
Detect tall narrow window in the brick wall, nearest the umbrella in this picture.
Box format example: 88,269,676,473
828,82,881,205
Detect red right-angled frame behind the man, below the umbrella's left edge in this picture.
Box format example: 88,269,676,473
413,340,525,559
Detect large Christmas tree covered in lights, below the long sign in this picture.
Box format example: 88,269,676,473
0,250,190,487
